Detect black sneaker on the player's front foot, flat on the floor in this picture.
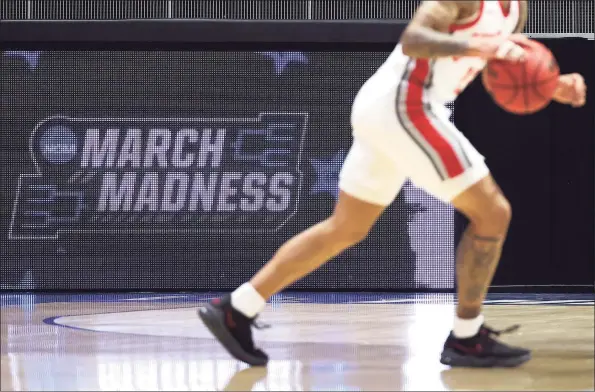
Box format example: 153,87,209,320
440,325,531,367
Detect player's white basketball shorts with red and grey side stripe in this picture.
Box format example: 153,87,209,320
339,62,489,205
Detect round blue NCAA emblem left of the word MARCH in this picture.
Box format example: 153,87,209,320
39,125,78,164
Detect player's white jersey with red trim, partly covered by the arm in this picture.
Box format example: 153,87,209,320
382,0,520,103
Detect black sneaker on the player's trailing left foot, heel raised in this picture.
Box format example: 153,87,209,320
198,295,269,366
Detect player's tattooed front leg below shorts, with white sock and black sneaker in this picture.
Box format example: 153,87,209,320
441,175,531,367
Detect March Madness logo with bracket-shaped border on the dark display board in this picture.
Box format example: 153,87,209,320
10,113,308,238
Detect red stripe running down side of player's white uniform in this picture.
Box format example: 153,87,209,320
405,59,465,178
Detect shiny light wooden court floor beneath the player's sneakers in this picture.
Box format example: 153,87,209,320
0,293,594,391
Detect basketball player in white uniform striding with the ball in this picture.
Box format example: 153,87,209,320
199,0,586,367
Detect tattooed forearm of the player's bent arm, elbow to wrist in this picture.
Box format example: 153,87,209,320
401,26,469,58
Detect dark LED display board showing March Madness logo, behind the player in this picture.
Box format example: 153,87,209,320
0,51,454,290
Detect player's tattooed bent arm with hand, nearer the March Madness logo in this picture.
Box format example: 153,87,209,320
401,0,522,60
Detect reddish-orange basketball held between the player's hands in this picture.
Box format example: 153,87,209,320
482,38,560,115
